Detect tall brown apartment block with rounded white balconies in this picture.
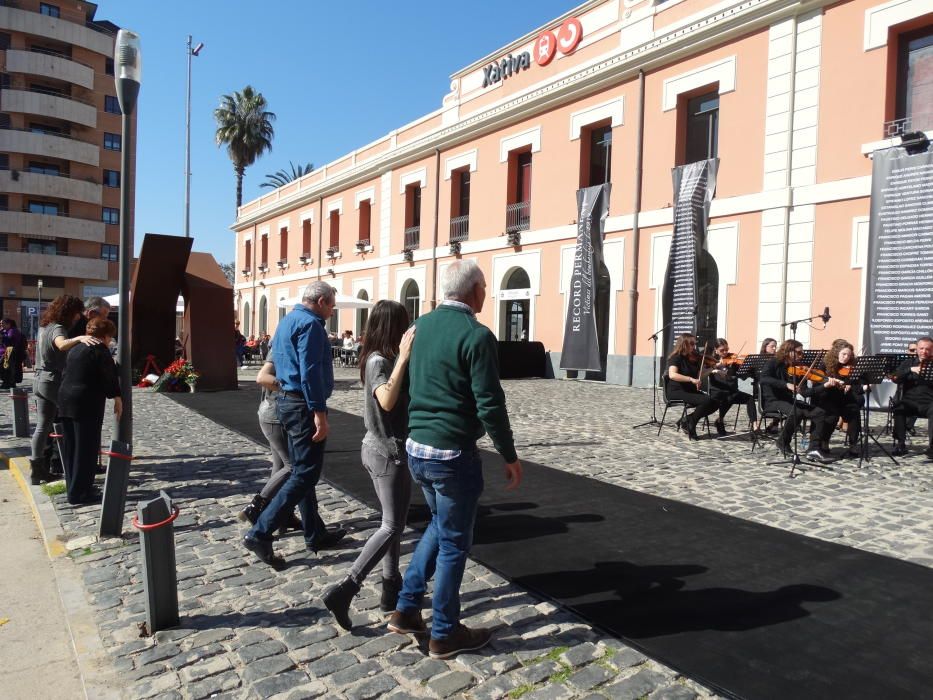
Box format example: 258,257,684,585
0,0,135,338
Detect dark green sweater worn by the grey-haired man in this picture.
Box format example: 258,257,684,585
408,305,517,462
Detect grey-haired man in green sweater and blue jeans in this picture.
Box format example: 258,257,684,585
388,260,522,659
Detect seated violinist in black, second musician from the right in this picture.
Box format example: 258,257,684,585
810,339,865,457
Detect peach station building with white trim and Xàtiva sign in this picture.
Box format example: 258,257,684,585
232,0,933,385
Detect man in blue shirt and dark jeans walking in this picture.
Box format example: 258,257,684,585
243,280,346,570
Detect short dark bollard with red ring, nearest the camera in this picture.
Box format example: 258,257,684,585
133,491,178,634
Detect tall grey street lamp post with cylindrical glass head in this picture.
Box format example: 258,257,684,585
114,29,142,445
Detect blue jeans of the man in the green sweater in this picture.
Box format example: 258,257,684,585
397,447,483,639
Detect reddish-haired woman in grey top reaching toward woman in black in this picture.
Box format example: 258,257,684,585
29,294,100,486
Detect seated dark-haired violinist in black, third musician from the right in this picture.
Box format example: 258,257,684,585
761,340,830,459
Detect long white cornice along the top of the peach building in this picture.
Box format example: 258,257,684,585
230,0,835,232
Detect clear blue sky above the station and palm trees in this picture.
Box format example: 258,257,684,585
107,0,579,263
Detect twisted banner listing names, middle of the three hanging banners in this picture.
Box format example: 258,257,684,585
662,159,719,357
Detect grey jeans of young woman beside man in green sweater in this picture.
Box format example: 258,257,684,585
349,445,411,585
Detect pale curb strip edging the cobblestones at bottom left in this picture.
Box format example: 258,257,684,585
0,452,121,700
